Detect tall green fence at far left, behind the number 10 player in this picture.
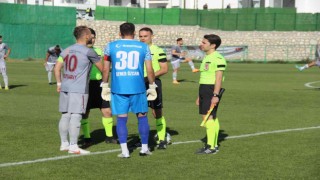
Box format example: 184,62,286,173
0,3,76,59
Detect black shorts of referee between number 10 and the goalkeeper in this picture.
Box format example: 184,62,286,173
87,80,110,110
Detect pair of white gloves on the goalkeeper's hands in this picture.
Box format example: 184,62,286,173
101,83,158,101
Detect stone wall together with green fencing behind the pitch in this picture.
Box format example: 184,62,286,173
0,3,320,62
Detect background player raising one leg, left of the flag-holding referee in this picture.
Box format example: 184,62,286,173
171,38,199,84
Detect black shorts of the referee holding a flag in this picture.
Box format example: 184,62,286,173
199,84,222,119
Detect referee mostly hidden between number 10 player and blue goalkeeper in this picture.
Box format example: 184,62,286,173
81,28,117,147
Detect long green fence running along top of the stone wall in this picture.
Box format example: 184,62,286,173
95,6,320,31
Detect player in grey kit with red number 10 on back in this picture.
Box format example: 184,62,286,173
54,26,103,154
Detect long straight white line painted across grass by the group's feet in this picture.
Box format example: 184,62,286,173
0,126,320,168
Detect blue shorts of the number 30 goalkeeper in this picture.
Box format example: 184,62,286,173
111,92,148,115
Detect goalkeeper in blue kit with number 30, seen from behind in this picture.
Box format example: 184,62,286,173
101,23,157,158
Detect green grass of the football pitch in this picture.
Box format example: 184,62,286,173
0,61,320,180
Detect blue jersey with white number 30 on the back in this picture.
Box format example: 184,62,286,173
104,39,152,94
